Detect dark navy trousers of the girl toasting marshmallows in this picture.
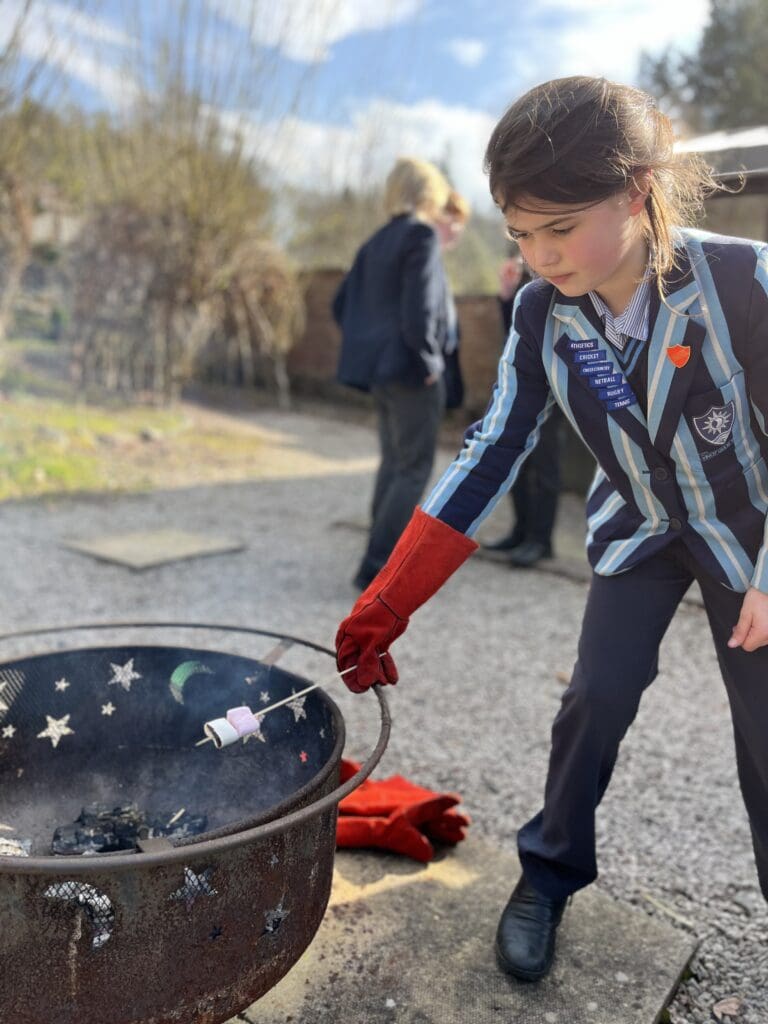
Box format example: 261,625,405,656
518,539,768,899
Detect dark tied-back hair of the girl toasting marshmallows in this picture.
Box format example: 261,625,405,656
484,77,720,287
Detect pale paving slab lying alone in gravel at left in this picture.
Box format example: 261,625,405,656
63,529,245,569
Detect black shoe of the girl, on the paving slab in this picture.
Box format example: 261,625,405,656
496,876,567,981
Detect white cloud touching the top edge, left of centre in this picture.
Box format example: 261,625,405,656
214,0,424,63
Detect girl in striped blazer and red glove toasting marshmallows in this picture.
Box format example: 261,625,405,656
337,78,768,980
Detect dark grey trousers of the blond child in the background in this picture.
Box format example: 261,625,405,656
358,378,445,582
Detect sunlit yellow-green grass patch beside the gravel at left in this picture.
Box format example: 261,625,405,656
0,342,371,501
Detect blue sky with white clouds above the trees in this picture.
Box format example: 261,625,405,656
9,0,709,206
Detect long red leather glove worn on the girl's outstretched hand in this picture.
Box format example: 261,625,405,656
336,508,477,693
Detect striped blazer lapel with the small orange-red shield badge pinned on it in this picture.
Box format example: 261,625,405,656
648,250,707,454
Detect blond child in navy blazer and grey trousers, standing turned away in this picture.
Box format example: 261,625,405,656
333,158,451,589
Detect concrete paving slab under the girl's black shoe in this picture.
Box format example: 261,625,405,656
238,840,696,1024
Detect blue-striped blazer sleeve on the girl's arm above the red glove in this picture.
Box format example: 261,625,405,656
423,292,555,537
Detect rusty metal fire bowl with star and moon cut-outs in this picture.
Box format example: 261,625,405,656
0,623,390,1024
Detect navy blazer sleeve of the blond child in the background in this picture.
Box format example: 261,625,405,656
400,223,443,377
